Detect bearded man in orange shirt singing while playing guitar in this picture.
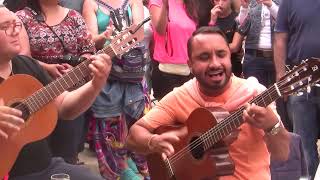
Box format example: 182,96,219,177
127,27,289,180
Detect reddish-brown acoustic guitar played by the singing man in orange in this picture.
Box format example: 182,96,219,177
147,58,320,180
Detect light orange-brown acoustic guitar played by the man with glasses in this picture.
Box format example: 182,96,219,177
0,18,150,179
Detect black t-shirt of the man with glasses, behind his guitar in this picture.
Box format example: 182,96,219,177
9,56,52,177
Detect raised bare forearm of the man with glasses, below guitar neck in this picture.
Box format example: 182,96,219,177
59,80,101,120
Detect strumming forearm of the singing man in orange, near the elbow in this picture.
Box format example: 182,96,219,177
126,124,153,154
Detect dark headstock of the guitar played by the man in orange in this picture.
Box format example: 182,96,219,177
277,58,320,95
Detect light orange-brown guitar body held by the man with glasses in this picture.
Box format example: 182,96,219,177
0,75,58,179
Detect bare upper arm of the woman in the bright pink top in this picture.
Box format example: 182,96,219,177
149,0,169,35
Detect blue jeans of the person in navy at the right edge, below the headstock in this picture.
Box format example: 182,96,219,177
287,87,320,177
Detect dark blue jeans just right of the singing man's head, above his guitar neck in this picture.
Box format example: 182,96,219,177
243,52,276,88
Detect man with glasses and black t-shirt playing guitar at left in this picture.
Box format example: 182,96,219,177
0,5,111,180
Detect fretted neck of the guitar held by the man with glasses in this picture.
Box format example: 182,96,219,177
25,46,115,113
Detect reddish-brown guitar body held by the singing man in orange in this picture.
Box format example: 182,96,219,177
147,108,234,180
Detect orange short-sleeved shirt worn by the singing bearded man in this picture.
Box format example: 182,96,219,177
142,76,277,180
